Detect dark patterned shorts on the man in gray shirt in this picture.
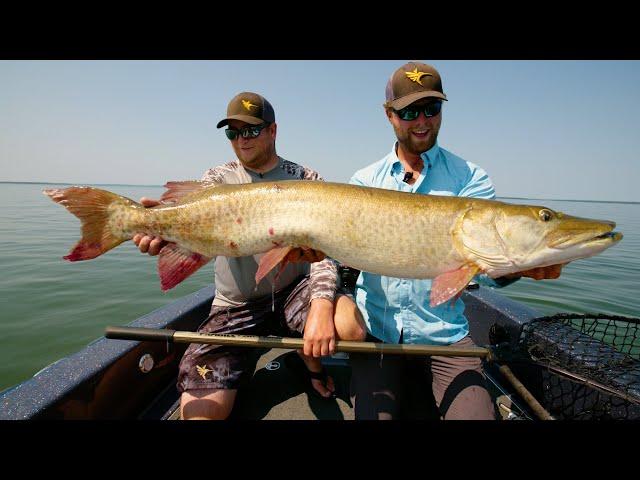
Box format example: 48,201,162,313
177,275,309,392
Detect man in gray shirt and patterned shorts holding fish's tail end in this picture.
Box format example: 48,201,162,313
134,92,366,419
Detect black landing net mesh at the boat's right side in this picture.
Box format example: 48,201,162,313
518,313,640,420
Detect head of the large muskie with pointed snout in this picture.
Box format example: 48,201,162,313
459,202,622,278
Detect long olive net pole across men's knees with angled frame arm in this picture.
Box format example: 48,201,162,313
105,326,554,420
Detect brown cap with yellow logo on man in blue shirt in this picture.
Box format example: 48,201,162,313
384,62,447,110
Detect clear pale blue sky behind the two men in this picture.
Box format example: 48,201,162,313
0,58,640,202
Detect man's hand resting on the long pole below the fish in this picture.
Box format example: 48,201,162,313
303,298,336,358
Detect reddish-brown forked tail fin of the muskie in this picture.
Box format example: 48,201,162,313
42,187,135,262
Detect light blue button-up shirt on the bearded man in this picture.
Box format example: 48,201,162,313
349,143,500,345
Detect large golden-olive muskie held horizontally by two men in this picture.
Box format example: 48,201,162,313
44,181,622,306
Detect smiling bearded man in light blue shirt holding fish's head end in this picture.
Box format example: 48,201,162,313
350,62,560,419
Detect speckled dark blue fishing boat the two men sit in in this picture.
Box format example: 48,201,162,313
0,268,640,420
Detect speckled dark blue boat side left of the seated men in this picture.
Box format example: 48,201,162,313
0,285,214,420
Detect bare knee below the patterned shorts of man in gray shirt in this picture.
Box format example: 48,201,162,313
180,390,237,420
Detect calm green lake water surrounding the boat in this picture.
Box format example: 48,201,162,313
0,183,640,390
